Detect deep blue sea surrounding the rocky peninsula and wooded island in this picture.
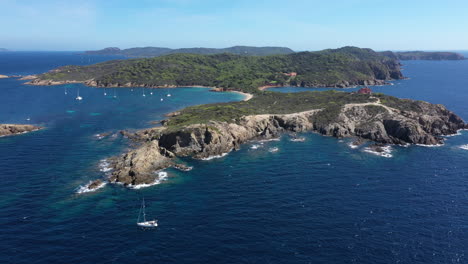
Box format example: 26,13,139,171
0,52,468,264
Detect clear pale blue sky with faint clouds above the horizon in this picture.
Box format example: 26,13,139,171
0,0,468,50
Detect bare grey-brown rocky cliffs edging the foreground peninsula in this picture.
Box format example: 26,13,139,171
111,101,467,184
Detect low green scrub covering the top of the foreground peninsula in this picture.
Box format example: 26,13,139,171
167,90,376,129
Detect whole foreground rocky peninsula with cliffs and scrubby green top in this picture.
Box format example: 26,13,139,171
104,91,468,185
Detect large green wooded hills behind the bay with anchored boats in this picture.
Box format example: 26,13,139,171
39,47,402,93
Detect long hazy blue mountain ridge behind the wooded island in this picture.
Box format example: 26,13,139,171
85,46,294,57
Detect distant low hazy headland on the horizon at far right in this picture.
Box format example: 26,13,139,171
381,51,465,60
